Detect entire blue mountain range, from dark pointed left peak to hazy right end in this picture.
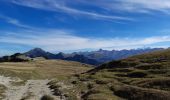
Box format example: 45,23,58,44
23,48,163,65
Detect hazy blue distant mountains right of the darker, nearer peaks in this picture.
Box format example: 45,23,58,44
78,48,163,63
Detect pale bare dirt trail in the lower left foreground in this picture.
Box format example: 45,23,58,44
0,76,61,100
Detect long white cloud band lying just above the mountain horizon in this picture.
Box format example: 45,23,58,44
0,30,170,52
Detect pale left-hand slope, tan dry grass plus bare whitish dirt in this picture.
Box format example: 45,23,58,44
0,58,92,100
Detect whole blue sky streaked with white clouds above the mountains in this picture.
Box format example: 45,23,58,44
0,0,170,55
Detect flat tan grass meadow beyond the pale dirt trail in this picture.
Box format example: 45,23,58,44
0,60,92,80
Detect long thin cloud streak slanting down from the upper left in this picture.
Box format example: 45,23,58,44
7,0,134,21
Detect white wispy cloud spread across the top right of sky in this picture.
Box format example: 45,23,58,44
82,0,170,14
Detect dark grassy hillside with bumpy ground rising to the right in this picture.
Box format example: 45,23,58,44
60,49,170,100
